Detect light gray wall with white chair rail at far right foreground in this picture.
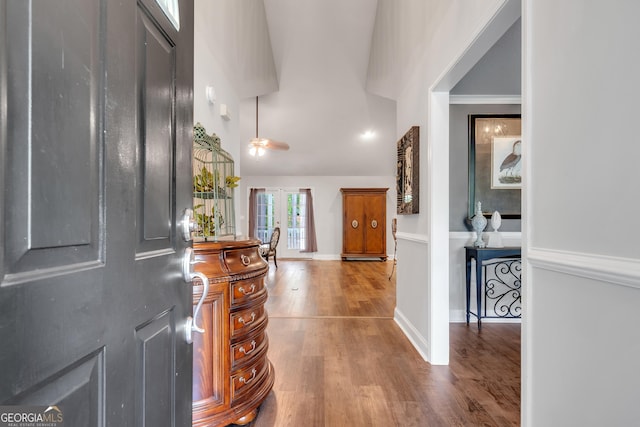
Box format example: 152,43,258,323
522,0,640,426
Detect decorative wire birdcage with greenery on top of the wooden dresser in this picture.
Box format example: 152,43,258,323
193,123,240,241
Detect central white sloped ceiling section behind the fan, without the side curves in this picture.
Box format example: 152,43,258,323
236,0,396,176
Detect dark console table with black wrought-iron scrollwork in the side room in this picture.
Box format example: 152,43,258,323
464,246,522,329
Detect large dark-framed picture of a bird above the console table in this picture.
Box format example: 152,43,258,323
468,114,522,219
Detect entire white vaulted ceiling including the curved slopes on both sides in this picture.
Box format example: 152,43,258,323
202,0,446,176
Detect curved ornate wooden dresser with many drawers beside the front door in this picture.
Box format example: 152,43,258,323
193,239,274,426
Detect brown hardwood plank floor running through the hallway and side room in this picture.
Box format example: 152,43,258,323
240,260,520,427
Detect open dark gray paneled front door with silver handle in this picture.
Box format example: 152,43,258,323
0,0,193,427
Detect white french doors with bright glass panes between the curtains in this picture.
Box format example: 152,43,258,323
256,188,308,258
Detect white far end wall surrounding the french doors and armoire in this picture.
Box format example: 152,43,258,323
236,176,396,259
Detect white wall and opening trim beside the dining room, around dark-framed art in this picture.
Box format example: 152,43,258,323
395,0,517,364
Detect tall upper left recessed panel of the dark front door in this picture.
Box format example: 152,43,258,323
2,1,104,282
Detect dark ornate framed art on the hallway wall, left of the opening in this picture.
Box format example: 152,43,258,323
396,126,420,214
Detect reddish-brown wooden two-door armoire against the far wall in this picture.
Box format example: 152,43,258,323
340,188,388,261
